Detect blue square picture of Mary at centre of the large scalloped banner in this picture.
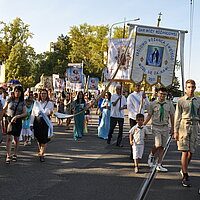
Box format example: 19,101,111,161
146,45,164,67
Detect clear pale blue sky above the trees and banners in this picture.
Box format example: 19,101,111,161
0,0,200,91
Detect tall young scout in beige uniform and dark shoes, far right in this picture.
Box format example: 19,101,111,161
174,80,200,187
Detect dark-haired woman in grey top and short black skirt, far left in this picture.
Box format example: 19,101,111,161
3,86,26,164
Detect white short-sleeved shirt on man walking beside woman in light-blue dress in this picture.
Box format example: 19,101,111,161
110,94,127,118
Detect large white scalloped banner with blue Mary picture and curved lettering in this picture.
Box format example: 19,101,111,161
131,26,179,87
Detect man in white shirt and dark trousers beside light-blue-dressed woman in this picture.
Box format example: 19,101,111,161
107,86,127,147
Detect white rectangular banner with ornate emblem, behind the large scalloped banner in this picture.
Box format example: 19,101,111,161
107,38,134,81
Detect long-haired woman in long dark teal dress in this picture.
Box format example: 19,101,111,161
73,91,86,140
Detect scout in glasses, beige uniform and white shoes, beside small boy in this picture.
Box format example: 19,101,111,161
144,88,175,172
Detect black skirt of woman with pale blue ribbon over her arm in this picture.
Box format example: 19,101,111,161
33,117,50,144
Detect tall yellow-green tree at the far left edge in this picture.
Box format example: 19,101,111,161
0,18,35,87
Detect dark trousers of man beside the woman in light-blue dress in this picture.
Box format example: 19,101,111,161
108,117,124,145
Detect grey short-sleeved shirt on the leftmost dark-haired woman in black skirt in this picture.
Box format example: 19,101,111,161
6,97,26,117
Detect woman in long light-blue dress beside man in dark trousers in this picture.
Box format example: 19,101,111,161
98,92,111,140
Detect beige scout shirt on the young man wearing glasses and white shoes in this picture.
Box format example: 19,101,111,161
148,100,175,126
